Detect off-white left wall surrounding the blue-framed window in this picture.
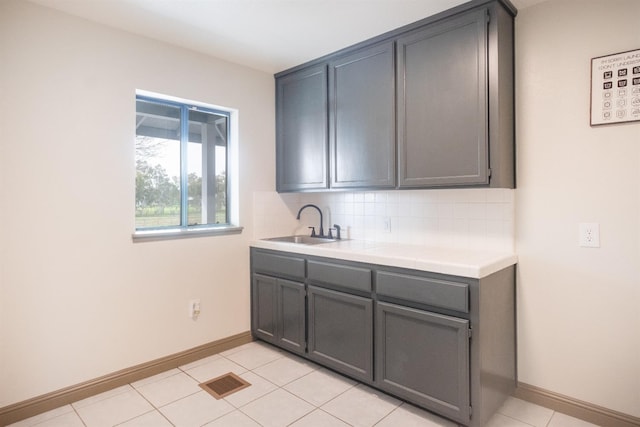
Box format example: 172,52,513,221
0,0,275,407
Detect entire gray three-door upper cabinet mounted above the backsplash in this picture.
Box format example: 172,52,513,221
275,0,516,192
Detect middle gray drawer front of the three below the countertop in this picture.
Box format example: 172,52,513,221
307,261,371,292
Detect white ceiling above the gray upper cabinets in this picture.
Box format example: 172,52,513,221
30,0,551,73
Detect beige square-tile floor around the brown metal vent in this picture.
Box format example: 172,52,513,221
12,342,593,427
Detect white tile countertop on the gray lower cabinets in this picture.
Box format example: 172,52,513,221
251,240,518,279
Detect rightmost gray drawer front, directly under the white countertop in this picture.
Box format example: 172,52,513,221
376,271,469,313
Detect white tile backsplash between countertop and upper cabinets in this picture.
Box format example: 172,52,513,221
253,189,515,251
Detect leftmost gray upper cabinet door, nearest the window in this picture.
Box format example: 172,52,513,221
276,65,329,192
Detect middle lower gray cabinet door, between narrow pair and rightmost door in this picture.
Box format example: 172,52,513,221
308,286,373,381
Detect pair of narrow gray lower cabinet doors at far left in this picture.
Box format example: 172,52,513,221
251,274,306,354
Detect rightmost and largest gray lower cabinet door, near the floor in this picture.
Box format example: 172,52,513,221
376,303,470,424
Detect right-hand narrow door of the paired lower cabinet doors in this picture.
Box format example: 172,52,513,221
278,279,306,353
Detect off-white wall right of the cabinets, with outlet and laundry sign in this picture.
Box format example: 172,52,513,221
515,0,640,416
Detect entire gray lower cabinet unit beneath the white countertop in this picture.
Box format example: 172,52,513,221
251,248,516,427
